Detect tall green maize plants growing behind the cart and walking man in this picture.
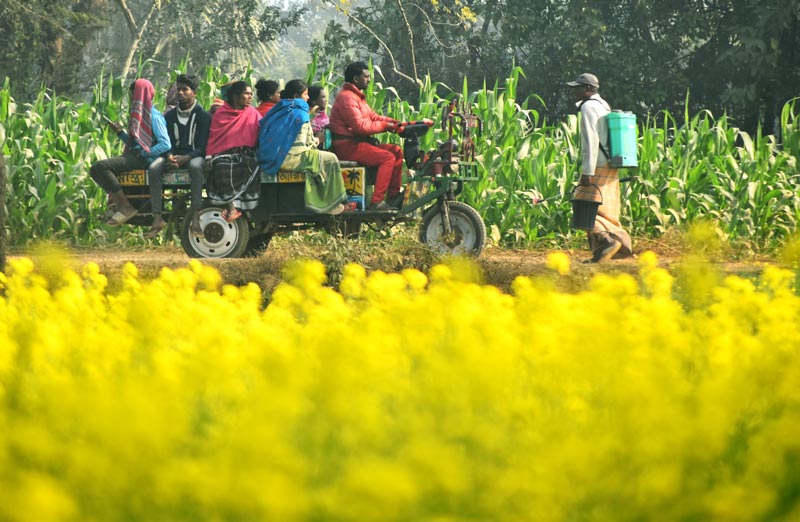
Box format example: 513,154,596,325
0,62,800,250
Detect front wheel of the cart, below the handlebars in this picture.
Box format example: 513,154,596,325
419,201,486,256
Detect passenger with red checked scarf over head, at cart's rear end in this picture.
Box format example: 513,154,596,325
89,79,170,227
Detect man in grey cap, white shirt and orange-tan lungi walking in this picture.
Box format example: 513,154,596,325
567,73,632,263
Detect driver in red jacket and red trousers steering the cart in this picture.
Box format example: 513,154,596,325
330,62,403,210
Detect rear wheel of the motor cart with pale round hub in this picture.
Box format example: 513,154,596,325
181,207,250,257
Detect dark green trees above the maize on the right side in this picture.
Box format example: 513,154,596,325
321,0,800,130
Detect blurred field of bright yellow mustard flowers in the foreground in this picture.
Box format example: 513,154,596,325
0,253,800,521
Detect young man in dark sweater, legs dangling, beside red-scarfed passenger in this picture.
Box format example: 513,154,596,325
145,74,211,237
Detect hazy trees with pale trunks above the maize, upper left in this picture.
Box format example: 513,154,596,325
0,0,305,99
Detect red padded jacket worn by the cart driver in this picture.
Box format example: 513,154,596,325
329,83,395,139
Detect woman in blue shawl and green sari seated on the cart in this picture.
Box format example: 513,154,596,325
258,80,347,215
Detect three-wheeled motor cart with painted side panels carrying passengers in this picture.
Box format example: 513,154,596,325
112,98,486,258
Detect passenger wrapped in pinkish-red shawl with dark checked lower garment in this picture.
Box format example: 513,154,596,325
206,80,261,223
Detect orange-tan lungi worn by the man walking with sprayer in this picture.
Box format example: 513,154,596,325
574,167,632,259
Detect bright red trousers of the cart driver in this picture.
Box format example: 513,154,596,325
333,140,403,203
